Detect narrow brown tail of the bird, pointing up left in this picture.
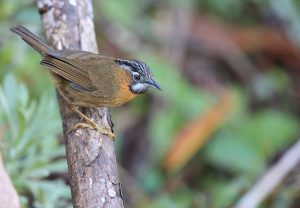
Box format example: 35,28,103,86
10,25,52,56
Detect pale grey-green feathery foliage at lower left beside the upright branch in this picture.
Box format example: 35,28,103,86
0,74,70,207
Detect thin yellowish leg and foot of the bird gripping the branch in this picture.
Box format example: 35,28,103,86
71,106,115,140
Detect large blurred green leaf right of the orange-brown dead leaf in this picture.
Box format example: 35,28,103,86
204,105,298,175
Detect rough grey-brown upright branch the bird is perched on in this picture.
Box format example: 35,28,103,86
38,0,123,208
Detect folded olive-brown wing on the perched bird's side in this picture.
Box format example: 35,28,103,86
41,50,120,97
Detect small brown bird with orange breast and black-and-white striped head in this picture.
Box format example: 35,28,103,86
10,25,161,138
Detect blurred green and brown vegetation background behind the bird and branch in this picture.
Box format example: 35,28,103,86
0,0,300,208
